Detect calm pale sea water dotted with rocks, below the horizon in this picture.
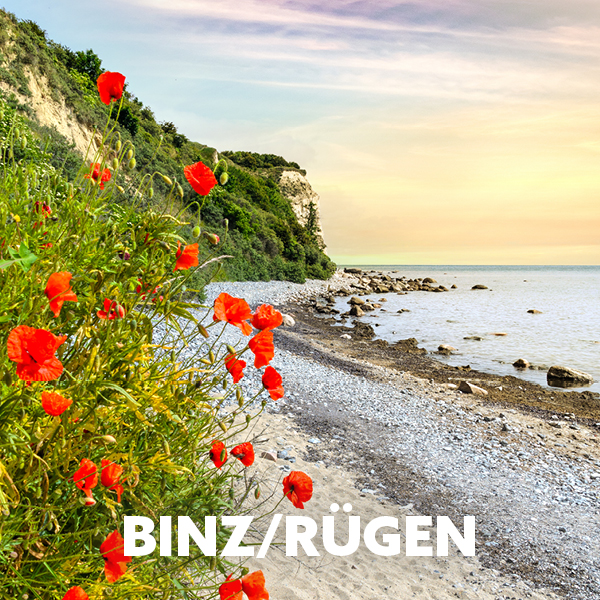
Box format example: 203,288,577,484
336,266,600,392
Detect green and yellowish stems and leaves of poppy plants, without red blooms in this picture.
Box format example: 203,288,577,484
0,95,276,600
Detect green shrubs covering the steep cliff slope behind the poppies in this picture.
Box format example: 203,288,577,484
0,10,335,282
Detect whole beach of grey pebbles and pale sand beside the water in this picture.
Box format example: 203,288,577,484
172,272,600,600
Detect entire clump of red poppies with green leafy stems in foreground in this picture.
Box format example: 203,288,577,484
0,72,312,600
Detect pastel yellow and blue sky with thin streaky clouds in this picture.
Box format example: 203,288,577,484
0,0,600,265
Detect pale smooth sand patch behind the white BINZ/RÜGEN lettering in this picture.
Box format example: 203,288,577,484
233,414,558,600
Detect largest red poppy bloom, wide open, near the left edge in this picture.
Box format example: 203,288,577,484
6,325,67,381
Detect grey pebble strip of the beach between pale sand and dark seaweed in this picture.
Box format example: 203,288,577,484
165,281,600,600
